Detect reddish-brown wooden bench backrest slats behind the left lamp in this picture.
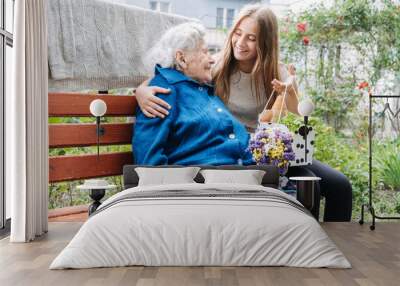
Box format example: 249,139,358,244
48,93,137,183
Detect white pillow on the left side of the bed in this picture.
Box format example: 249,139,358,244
135,167,200,186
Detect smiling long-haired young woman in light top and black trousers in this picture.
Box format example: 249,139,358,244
136,4,352,221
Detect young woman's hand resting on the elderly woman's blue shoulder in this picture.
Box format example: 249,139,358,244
135,81,171,118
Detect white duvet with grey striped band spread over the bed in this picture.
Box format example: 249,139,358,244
50,184,351,269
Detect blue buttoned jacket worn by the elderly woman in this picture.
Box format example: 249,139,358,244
132,66,254,165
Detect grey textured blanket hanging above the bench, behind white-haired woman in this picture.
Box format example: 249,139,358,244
48,0,193,91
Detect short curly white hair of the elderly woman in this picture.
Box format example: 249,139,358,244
145,22,206,71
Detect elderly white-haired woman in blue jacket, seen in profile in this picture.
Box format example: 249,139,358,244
132,23,253,165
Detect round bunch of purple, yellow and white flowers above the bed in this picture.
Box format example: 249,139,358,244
249,123,295,175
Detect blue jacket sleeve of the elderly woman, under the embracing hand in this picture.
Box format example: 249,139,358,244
132,76,177,165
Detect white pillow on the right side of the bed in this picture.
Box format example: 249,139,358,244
200,170,265,185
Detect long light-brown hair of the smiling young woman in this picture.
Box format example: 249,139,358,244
213,4,281,108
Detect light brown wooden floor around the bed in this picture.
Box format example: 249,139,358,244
0,222,400,286
